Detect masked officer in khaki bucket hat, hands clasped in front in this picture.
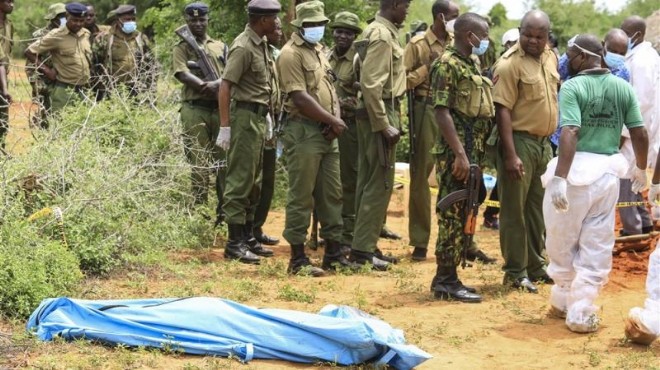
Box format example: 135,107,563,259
277,0,349,276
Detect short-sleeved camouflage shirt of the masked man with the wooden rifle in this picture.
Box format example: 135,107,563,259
431,46,493,157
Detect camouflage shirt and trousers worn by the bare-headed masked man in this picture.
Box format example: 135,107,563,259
431,46,493,266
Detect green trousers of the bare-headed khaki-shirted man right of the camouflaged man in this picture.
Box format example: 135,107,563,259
496,131,552,281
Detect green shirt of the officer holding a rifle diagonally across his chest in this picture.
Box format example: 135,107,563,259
172,35,226,101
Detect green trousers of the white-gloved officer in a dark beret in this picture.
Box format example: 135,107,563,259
222,105,267,225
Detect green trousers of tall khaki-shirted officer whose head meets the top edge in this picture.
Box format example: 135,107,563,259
351,104,401,253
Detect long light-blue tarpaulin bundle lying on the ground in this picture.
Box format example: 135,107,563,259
27,297,431,369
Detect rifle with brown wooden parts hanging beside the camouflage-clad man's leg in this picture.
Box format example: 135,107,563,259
436,164,482,268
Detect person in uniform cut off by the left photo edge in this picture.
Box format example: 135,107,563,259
0,0,14,150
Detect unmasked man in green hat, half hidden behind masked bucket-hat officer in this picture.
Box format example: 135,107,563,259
328,12,362,254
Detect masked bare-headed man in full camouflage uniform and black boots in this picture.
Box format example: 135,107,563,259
431,13,495,302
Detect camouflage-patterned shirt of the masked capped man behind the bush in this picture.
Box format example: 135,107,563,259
92,27,153,82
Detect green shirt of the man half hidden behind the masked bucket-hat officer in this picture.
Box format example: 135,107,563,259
328,46,358,118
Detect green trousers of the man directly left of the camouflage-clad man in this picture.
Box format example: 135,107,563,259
408,101,438,248
